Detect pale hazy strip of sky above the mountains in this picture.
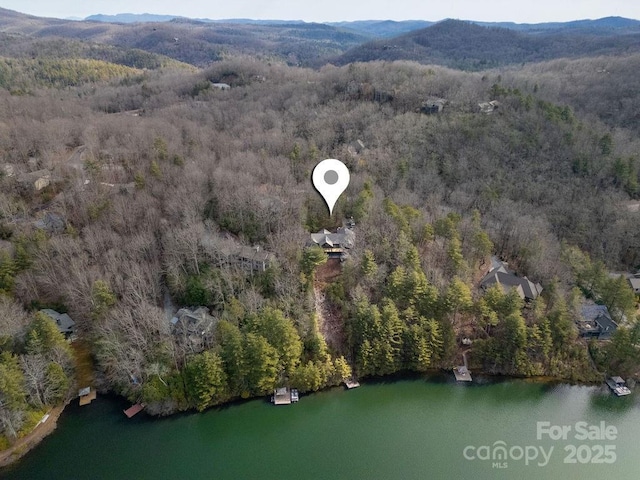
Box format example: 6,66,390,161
0,0,640,23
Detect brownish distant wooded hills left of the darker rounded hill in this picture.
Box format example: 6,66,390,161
0,8,369,67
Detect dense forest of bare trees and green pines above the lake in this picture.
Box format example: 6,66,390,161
0,8,640,454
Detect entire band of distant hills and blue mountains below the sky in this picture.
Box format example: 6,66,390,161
0,8,640,70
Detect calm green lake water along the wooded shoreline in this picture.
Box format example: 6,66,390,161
0,377,640,480
